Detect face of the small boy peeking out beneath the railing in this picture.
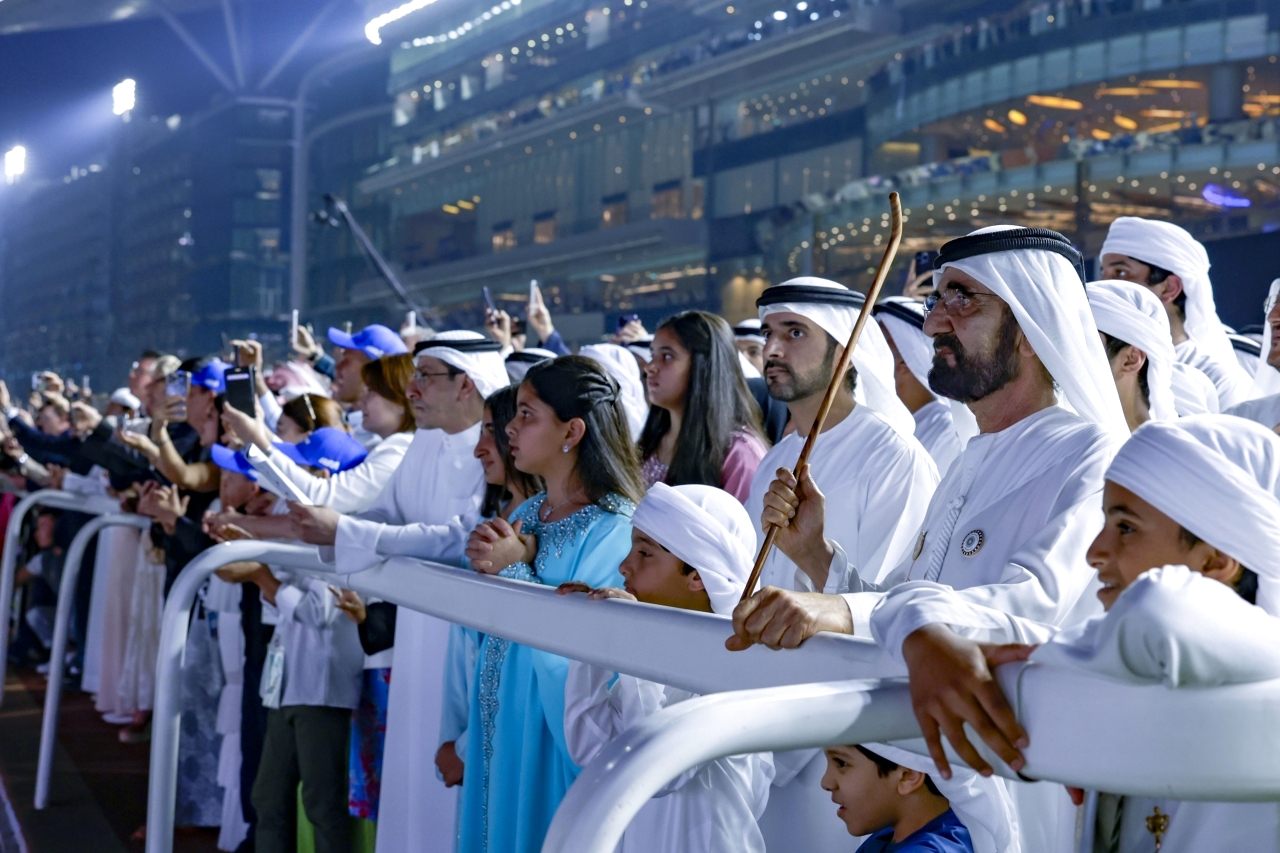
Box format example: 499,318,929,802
822,747,924,835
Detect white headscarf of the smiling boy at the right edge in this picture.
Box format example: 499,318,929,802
1106,415,1280,615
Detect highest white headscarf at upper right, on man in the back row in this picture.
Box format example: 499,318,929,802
1098,216,1244,373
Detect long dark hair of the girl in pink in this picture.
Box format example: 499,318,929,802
640,311,768,488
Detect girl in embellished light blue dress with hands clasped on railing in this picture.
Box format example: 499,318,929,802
460,356,643,853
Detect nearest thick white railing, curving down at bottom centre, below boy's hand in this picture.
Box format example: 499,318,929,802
555,663,1280,853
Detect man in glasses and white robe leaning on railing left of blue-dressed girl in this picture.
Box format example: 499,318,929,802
289,330,507,853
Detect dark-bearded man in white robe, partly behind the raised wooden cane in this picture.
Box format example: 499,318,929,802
746,278,938,853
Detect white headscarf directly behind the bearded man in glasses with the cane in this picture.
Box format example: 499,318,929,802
1084,279,1178,420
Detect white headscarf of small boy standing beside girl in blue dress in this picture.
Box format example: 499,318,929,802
631,483,755,616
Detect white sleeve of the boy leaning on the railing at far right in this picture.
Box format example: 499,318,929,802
1032,566,1280,688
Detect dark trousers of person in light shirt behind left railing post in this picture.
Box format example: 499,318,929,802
253,704,351,853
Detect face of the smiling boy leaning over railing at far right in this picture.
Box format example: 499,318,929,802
1087,480,1240,610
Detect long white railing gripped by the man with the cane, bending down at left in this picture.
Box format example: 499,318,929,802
146,542,902,853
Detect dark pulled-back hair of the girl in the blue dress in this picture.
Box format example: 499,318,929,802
522,356,644,503
